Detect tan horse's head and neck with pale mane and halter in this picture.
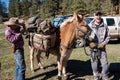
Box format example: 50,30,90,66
60,12,91,47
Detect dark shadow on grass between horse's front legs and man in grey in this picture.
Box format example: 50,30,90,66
67,60,92,80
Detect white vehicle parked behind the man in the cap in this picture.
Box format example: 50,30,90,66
76,16,120,47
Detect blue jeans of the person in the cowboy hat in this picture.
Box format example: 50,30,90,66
14,49,26,80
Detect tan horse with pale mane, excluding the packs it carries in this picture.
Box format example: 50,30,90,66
29,13,89,79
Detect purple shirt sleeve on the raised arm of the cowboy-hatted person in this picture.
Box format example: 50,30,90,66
5,30,21,43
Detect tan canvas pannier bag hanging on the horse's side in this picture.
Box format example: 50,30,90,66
33,33,56,51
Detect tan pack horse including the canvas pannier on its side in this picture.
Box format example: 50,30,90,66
29,12,90,79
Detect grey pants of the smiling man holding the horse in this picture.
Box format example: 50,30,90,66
90,49,109,80
